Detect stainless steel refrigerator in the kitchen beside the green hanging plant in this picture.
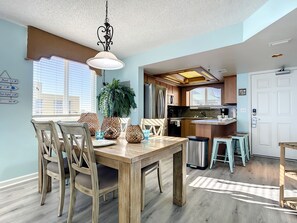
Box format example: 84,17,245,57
144,84,167,118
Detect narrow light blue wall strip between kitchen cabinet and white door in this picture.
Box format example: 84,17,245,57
237,74,251,132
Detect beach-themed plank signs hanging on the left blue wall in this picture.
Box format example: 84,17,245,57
0,70,19,104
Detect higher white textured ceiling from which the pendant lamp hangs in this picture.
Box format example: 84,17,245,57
0,0,266,58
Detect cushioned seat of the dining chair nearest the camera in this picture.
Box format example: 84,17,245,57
75,165,118,190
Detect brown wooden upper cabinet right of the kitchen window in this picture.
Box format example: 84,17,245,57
224,75,237,104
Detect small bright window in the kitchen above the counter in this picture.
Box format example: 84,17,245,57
190,87,221,106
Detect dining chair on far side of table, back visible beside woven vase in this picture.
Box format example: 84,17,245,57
140,118,165,211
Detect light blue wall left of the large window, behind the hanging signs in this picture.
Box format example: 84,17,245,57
0,20,37,181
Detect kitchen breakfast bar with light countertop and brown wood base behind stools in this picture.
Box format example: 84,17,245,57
191,119,236,162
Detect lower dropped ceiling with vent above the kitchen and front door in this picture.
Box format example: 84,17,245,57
144,9,297,79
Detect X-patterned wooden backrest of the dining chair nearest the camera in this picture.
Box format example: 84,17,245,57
58,122,99,190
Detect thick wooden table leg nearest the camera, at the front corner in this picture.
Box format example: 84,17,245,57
118,162,141,223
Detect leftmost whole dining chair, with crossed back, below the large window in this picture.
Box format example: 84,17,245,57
31,119,69,216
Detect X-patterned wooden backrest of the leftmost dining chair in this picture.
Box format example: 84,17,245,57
31,119,64,174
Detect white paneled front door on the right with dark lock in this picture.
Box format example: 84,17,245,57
252,70,297,159
